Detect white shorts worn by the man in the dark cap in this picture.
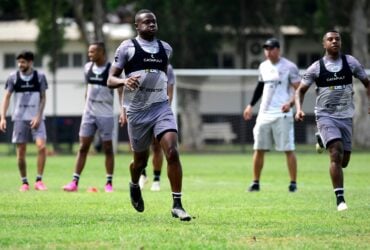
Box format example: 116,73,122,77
253,116,295,151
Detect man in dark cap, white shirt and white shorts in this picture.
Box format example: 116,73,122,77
243,38,301,192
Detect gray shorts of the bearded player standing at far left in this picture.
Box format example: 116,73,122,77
12,121,46,143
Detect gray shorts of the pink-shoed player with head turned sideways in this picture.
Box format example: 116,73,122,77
78,114,114,141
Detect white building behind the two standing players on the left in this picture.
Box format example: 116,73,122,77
0,21,135,116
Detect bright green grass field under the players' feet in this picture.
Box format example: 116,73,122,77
0,151,370,249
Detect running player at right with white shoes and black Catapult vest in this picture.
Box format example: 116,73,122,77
295,30,370,211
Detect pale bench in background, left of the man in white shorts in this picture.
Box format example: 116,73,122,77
202,122,236,143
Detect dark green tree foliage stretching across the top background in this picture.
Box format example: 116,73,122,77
0,0,366,68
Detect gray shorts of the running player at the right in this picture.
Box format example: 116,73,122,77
316,116,352,151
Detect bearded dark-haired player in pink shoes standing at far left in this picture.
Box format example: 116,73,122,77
0,51,48,192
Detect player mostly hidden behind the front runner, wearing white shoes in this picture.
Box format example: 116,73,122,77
139,64,176,191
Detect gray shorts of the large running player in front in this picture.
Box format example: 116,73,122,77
127,102,177,152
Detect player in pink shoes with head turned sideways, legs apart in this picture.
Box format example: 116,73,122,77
63,42,122,192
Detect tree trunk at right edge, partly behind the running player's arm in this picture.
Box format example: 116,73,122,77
351,0,370,147
